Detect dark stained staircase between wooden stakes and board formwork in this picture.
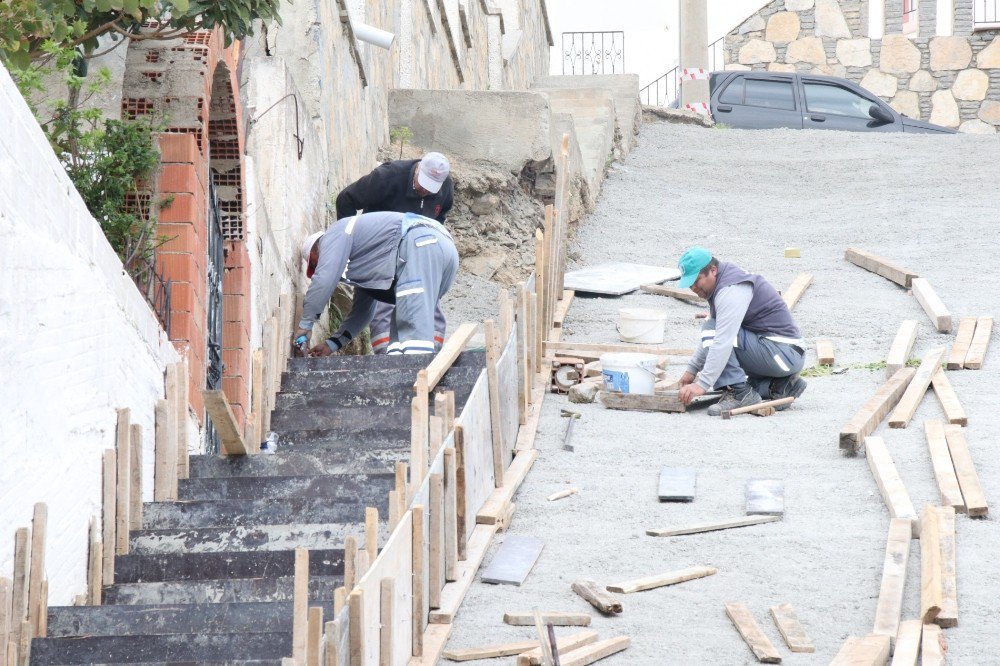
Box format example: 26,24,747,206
31,352,484,664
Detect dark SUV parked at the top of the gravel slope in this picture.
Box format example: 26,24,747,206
710,72,955,134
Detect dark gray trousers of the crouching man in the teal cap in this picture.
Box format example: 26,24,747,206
701,318,805,400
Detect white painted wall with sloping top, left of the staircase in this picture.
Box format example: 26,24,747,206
0,65,178,605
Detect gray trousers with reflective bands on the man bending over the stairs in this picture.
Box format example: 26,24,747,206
386,226,458,354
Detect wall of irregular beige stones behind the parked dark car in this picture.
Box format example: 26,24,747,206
725,0,1000,134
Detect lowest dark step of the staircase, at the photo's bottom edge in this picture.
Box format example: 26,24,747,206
31,631,292,665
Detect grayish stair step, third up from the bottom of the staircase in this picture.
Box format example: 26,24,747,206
104,575,344,605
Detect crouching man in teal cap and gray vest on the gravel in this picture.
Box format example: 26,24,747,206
678,247,806,416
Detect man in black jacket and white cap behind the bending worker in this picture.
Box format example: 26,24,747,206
337,152,455,354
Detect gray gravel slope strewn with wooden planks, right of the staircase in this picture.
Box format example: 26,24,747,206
449,124,1000,666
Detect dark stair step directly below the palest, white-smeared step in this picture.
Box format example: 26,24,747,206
115,544,344,580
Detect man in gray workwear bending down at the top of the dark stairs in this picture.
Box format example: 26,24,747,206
294,212,458,356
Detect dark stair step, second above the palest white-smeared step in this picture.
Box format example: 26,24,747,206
178,472,395,506
